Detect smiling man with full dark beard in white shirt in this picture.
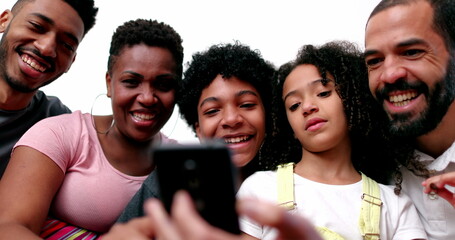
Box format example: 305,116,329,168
365,0,455,239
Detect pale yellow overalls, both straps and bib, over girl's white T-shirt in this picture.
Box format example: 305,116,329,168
277,163,382,240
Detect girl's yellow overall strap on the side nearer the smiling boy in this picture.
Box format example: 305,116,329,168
276,162,295,210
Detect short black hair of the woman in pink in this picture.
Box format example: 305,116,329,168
107,19,183,82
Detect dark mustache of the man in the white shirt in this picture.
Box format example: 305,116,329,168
376,80,430,102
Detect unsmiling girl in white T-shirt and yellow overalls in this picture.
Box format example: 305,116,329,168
238,42,426,239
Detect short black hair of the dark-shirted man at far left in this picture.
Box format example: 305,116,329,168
12,0,98,35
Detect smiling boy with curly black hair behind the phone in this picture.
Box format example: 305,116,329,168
119,43,275,222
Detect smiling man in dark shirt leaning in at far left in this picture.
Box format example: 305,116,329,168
0,0,98,178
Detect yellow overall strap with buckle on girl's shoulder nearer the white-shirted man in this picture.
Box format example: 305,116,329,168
359,173,382,240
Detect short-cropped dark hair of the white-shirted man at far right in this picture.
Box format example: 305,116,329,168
368,0,455,51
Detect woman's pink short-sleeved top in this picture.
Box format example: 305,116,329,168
15,111,176,232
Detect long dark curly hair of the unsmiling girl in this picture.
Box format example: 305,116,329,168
272,41,430,194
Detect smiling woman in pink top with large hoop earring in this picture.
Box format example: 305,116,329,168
0,19,183,239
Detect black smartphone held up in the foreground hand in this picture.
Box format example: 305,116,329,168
152,142,240,234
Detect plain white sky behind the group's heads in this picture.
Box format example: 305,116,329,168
0,0,379,143
